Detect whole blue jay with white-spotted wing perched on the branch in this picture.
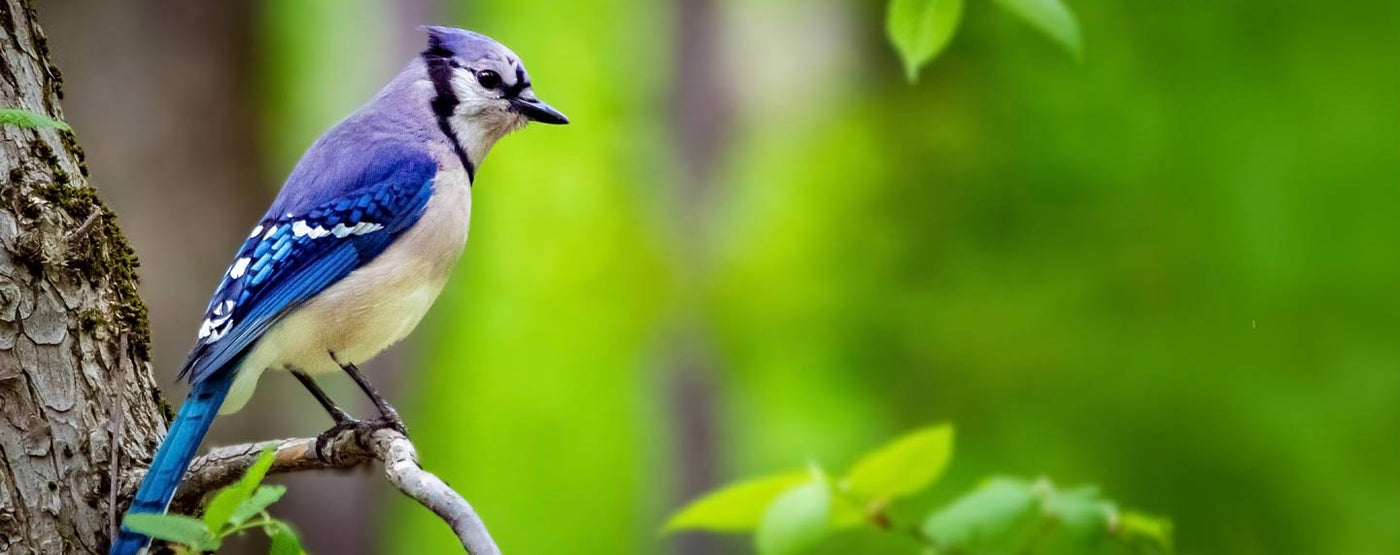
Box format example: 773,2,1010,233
111,27,568,555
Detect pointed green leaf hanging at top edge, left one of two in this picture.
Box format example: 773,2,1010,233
885,0,963,83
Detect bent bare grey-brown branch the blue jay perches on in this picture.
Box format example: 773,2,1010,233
123,429,501,555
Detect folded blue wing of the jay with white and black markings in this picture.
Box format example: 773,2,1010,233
181,145,437,384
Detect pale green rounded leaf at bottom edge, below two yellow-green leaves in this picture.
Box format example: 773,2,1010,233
755,475,832,555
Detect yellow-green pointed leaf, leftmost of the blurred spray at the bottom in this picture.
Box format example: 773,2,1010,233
665,471,812,533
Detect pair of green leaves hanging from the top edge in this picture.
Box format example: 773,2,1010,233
885,0,1084,81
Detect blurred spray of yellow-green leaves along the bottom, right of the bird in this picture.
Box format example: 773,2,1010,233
666,425,1172,555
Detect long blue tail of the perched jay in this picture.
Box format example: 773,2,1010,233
108,371,234,555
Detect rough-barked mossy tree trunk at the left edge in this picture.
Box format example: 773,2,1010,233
0,0,167,554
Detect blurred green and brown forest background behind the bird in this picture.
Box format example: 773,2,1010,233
39,0,1400,554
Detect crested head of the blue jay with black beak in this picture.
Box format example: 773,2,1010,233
423,27,568,139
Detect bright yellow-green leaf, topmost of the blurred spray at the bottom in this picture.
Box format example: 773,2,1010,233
844,425,953,502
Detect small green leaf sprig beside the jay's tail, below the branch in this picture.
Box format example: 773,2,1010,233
122,446,305,555
